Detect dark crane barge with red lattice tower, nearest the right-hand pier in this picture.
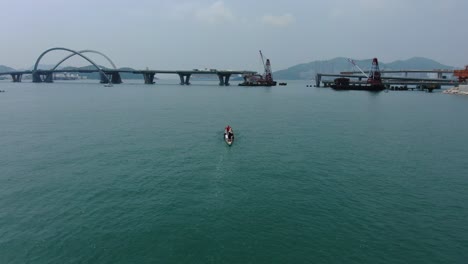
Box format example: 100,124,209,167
330,58,385,92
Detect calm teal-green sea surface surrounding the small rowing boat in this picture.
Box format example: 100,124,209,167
0,80,468,263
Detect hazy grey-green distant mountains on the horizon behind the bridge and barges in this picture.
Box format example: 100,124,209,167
0,57,455,80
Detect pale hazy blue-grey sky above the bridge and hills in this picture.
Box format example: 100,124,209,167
0,0,468,71
